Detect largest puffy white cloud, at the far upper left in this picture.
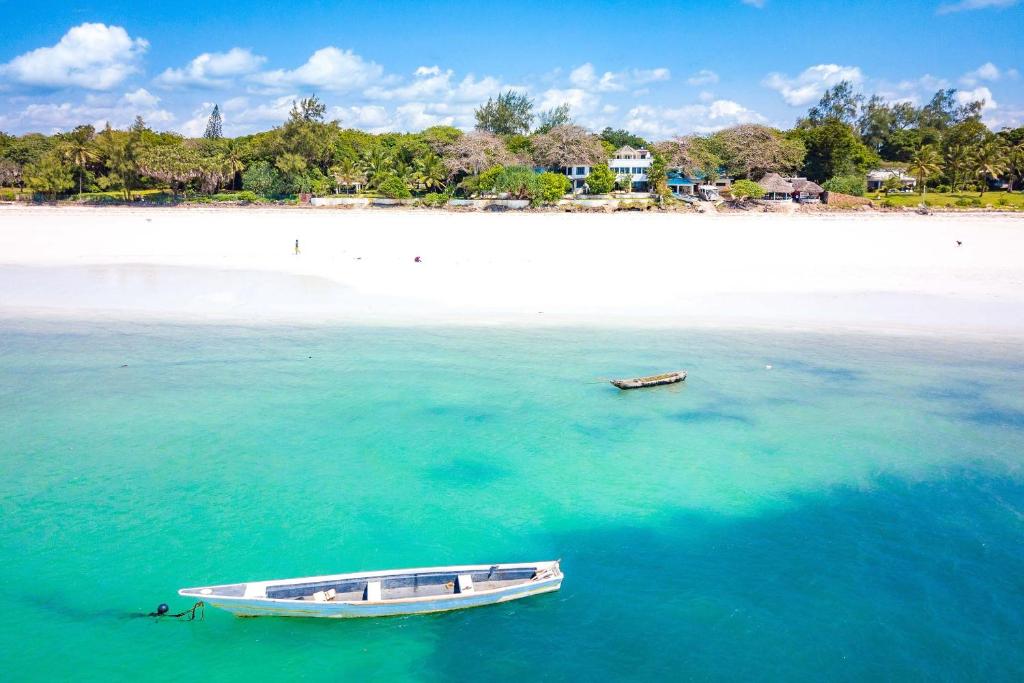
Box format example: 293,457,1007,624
0,24,150,90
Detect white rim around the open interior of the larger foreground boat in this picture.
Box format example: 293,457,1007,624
178,560,564,605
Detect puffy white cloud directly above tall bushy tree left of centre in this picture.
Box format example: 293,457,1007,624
250,47,384,92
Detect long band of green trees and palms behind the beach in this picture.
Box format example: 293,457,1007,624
0,82,1024,202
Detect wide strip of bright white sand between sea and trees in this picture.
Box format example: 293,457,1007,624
0,206,1024,336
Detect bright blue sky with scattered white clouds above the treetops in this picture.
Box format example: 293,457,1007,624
0,0,1024,139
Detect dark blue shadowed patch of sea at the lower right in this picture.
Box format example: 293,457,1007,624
417,473,1024,681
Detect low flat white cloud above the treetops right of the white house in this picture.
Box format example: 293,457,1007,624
625,99,766,139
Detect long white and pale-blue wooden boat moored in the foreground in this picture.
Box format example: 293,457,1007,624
178,560,562,618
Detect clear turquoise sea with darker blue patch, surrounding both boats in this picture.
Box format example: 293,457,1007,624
0,322,1024,681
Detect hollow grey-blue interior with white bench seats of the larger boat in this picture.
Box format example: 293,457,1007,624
266,566,538,602
